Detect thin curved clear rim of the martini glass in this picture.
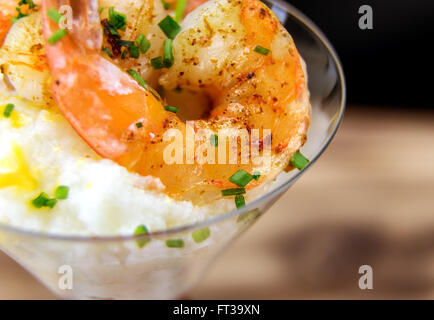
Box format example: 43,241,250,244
0,0,346,242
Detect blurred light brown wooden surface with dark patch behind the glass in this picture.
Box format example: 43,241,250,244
0,107,434,299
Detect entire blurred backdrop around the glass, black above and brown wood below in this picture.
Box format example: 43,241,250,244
0,0,434,299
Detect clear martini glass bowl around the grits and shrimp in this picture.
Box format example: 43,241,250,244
0,0,345,299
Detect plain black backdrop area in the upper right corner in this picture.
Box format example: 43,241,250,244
287,0,434,111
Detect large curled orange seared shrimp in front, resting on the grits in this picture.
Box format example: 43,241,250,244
42,0,309,201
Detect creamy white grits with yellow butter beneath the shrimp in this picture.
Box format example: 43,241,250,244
0,96,234,235
